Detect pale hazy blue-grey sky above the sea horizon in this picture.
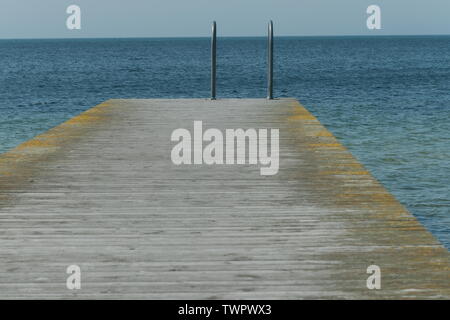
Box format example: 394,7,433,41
0,0,450,38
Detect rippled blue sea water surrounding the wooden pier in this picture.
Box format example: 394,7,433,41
0,36,450,248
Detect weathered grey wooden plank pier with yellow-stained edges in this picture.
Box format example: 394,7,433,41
0,99,450,299
